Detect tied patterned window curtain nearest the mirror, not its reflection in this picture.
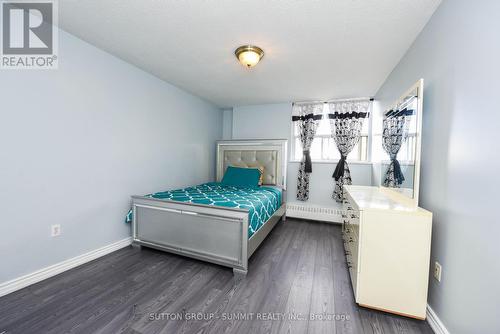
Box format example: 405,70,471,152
328,100,371,202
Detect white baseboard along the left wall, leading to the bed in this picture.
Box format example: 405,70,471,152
0,237,132,297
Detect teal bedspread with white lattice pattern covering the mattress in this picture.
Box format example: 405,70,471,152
126,182,282,238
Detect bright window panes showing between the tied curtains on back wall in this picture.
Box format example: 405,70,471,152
292,103,370,162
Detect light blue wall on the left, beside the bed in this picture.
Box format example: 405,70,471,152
0,32,222,283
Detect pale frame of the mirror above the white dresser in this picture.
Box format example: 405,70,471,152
380,79,424,206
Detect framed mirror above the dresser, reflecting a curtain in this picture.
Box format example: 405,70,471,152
373,79,423,205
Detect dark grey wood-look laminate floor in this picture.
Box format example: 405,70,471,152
0,219,432,334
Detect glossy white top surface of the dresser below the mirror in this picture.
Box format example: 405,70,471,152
344,186,431,215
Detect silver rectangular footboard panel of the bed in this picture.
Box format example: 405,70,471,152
132,196,248,274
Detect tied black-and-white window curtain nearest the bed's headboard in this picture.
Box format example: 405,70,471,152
292,103,323,201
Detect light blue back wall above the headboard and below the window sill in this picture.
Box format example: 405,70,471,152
232,103,372,208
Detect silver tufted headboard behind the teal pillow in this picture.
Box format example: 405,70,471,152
216,139,287,189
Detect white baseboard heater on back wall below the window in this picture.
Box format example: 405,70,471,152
286,202,342,224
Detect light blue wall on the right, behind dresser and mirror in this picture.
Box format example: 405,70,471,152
377,0,500,334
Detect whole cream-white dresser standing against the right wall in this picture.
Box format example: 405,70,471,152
342,186,432,319
